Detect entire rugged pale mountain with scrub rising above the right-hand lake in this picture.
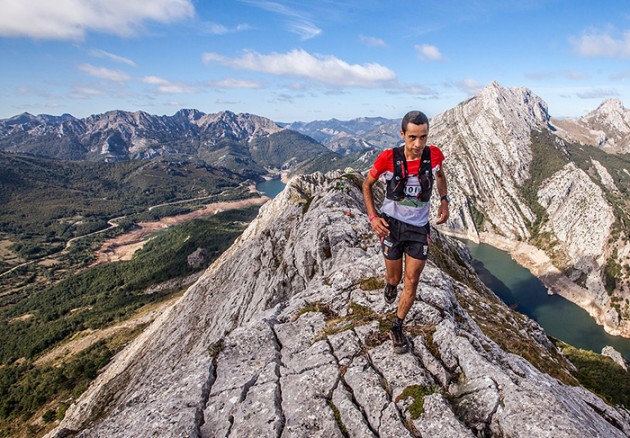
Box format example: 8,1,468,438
430,83,630,336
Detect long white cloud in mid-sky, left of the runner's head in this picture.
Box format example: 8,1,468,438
202,49,396,88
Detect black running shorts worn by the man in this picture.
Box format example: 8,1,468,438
381,215,431,260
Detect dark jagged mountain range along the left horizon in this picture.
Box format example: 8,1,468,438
0,110,330,178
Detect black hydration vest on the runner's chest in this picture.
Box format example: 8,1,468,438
385,145,433,202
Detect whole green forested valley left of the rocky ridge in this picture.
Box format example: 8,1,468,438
0,153,258,437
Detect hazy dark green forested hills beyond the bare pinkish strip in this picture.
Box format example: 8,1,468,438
0,153,251,264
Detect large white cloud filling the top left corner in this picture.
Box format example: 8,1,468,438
0,0,195,40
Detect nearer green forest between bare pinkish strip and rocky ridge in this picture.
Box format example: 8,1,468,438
0,207,258,436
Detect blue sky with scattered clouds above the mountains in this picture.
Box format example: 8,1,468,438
0,0,630,122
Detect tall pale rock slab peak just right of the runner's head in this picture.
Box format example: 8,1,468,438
430,82,549,240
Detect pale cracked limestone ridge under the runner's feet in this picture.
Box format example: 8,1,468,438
48,173,630,438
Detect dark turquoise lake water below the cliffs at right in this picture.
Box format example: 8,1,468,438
464,241,630,360
